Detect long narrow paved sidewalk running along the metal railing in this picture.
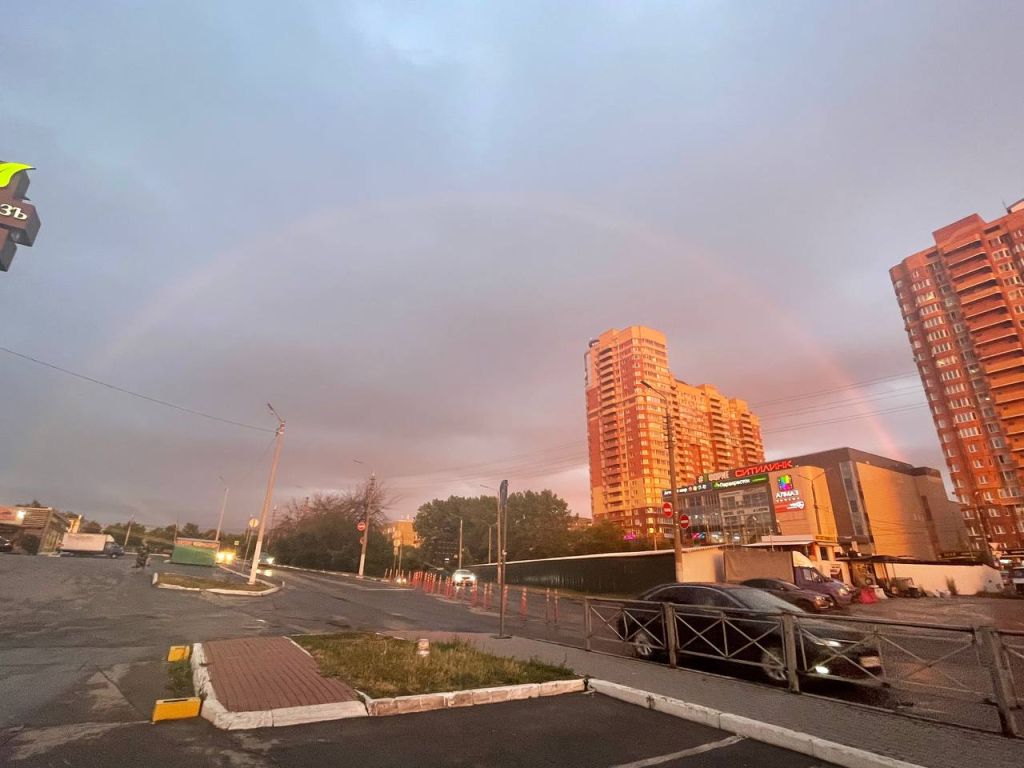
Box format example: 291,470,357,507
387,632,1024,768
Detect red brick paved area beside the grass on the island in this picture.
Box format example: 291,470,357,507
203,637,358,712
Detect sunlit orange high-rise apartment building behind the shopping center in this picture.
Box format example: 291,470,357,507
586,326,764,541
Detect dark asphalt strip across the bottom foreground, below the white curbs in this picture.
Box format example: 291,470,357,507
0,694,827,768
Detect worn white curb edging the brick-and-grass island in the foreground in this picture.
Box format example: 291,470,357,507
191,640,587,730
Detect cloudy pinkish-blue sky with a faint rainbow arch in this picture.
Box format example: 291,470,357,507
0,0,1024,528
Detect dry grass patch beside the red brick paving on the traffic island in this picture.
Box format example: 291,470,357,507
295,634,580,698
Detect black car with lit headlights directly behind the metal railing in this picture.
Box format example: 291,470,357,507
620,583,882,685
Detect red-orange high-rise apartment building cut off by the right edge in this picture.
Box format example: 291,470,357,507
890,201,1024,552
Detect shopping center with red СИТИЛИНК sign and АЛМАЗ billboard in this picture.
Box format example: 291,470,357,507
665,447,969,560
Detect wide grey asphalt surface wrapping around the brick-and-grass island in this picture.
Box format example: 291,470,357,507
0,557,839,768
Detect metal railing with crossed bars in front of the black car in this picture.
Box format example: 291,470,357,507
584,598,1024,736
